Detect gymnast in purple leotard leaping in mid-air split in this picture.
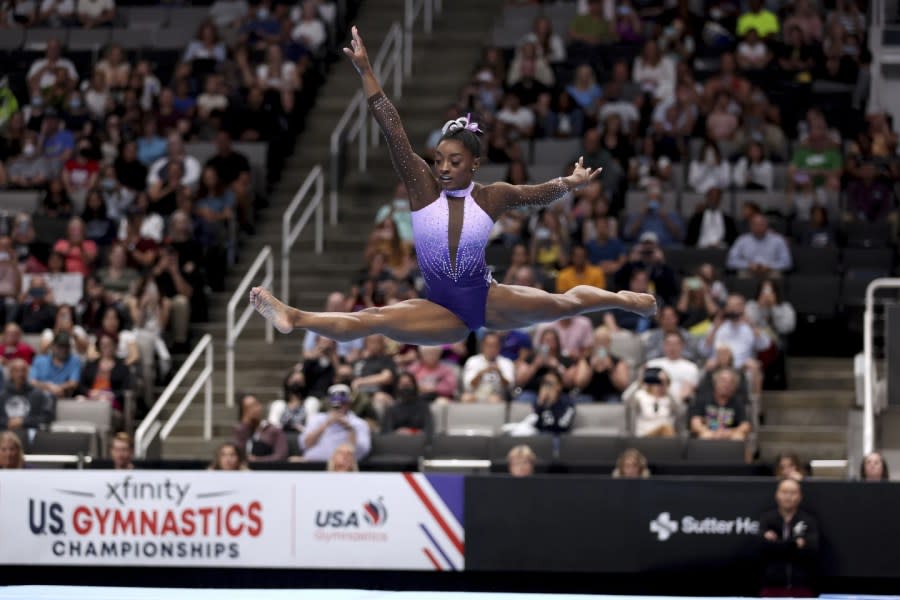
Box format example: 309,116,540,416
250,27,656,345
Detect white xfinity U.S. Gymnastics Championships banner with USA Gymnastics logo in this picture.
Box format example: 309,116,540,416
0,470,464,570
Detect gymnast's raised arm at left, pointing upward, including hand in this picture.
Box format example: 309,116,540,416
344,26,441,210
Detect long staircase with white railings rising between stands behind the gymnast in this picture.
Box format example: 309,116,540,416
156,0,502,459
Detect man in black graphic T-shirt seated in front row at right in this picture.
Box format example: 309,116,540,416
690,369,750,440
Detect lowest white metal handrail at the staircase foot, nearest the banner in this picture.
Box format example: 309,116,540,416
134,333,213,458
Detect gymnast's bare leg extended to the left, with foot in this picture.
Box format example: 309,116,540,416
250,287,469,345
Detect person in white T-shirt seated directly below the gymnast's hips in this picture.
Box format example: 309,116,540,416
460,332,516,403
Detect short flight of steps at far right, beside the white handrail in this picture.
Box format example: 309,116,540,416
759,357,856,463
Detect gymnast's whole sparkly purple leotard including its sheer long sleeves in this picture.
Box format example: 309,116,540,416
368,93,568,331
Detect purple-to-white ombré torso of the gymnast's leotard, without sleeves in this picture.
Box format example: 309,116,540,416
412,183,494,331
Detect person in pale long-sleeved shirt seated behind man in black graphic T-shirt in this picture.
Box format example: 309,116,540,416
703,294,772,393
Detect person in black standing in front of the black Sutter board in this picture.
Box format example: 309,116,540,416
759,479,819,598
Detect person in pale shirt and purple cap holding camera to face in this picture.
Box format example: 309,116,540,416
300,384,372,462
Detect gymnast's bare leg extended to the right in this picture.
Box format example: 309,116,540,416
487,284,656,330
